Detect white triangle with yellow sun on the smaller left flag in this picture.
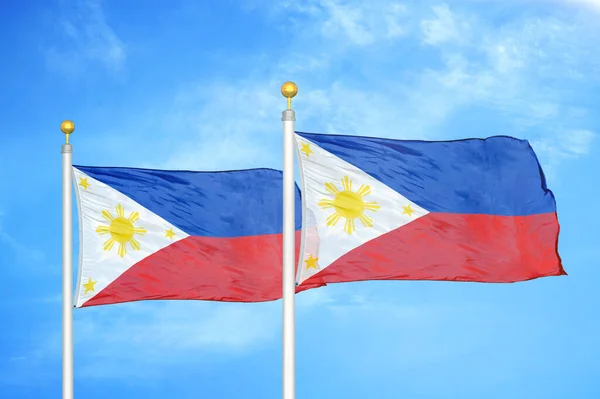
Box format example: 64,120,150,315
73,168,188,307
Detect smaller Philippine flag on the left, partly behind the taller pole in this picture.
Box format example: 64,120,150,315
73,166,301,307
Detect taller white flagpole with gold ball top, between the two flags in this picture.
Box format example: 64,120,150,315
281,82,298,399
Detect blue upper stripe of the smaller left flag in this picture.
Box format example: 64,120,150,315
75,166,302,237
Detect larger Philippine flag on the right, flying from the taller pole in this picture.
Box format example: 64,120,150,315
296,132,566,290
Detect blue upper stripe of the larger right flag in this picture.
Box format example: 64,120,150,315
297,132,556,216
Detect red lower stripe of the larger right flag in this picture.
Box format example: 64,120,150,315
301,213,566,290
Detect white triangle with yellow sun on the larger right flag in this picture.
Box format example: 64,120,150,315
296,134,429,284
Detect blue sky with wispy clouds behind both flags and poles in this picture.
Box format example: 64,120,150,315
0,0,600,399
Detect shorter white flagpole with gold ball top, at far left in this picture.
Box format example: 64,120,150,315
60,120,75,399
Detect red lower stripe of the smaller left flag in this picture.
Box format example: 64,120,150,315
83,231,300,307
